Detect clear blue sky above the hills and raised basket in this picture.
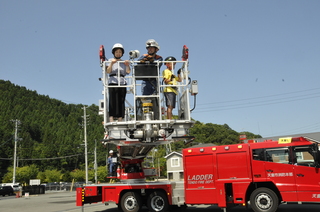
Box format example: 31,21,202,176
0,0,320,137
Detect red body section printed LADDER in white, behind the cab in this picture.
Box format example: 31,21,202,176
183,145,252,207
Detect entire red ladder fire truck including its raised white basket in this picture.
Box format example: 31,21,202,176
76,44,320,212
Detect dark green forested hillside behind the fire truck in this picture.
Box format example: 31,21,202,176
0,80,259,181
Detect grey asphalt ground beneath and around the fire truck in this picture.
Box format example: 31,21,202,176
0,191,320,212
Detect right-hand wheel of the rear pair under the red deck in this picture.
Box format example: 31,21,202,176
147,191,169,212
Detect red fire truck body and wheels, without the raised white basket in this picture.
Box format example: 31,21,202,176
77,137,320,212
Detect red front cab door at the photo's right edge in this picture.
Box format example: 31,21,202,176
293,146,320,202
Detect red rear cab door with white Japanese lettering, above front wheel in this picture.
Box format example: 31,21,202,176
265,147,297,201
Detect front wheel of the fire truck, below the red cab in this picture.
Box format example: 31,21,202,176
250,188,279,212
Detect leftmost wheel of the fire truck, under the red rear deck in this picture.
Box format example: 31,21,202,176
121,192,142,212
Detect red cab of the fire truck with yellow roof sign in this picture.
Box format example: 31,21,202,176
251,137,320,202
